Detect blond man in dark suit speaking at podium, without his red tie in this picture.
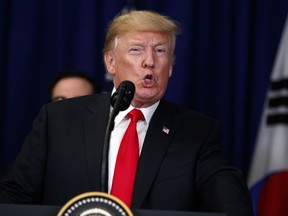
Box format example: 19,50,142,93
0,11,253,216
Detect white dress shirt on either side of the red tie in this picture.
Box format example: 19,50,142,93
108,98,159,193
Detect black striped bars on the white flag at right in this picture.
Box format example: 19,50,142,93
267,78,288,125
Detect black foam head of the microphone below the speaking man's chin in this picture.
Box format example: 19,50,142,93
110,80,135,111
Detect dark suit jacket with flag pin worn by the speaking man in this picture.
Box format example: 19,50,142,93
0,94,252,216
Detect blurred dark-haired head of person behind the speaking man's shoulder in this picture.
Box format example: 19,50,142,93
50,70,101,101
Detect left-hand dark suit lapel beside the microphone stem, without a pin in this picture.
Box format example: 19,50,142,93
84,94,110,191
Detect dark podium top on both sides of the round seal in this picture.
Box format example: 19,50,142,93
0,204,227,216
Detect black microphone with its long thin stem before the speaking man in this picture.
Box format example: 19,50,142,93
101,80,135,192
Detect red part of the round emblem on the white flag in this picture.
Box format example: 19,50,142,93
258,171,288,216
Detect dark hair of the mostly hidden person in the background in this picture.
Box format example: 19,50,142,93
49,70,102,97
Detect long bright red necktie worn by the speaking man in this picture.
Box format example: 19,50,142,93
111,109,144,207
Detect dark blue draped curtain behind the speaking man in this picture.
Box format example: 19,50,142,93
0,0,288,178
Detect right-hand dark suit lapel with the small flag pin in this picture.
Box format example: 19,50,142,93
132,101,174,208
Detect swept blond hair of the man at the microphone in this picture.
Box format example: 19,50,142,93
103,10,180,63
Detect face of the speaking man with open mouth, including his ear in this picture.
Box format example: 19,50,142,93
104,32,172,107
